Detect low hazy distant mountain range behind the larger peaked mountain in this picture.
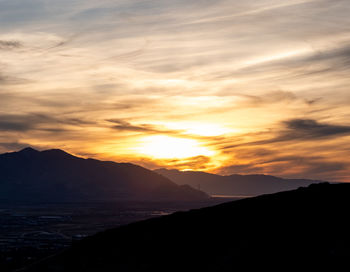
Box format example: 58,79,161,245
155,168,324,196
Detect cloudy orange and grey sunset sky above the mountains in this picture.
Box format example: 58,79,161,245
0,0,350,181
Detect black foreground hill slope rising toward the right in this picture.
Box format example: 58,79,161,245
23,184,350,272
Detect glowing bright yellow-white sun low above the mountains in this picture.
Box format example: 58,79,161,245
136,135,215,159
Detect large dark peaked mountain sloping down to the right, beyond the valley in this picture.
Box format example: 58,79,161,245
0,148,208,202
